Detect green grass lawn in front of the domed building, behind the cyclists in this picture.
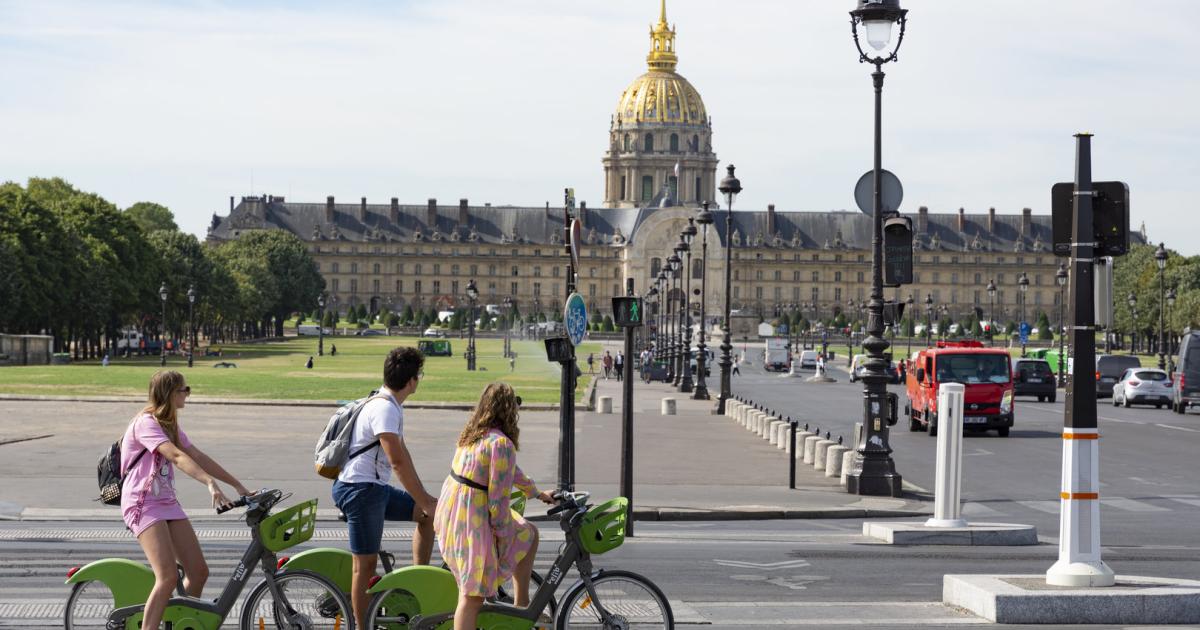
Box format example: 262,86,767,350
0,337,600,402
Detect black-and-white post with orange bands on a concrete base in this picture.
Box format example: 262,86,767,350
1046,133,1115,587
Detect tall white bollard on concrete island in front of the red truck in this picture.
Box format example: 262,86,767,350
925,383,967,527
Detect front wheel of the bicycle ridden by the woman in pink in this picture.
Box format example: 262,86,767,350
241,571,354,630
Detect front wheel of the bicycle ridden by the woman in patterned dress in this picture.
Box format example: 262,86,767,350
554,570,674,630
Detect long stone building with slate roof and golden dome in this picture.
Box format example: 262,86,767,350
208,2,1123,322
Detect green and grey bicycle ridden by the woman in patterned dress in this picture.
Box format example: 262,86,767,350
366,491,674,630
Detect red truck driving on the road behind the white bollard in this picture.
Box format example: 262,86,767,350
906,341,1013,437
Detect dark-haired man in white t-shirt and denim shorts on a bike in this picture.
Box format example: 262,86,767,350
334,347,434,628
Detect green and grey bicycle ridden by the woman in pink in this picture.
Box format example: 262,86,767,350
64,490,354,630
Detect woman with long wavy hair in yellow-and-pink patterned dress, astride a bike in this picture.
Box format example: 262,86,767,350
433,383,553,630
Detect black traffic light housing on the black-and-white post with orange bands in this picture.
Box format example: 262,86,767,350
1050,181,1129,257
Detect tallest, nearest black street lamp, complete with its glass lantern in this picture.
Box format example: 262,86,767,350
846,0,907,497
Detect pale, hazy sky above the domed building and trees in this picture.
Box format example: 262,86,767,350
0,0,1200,254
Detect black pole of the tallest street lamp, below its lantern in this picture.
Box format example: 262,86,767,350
846,63,904,497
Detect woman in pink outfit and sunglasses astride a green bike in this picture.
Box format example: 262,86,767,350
121,371,250,630
